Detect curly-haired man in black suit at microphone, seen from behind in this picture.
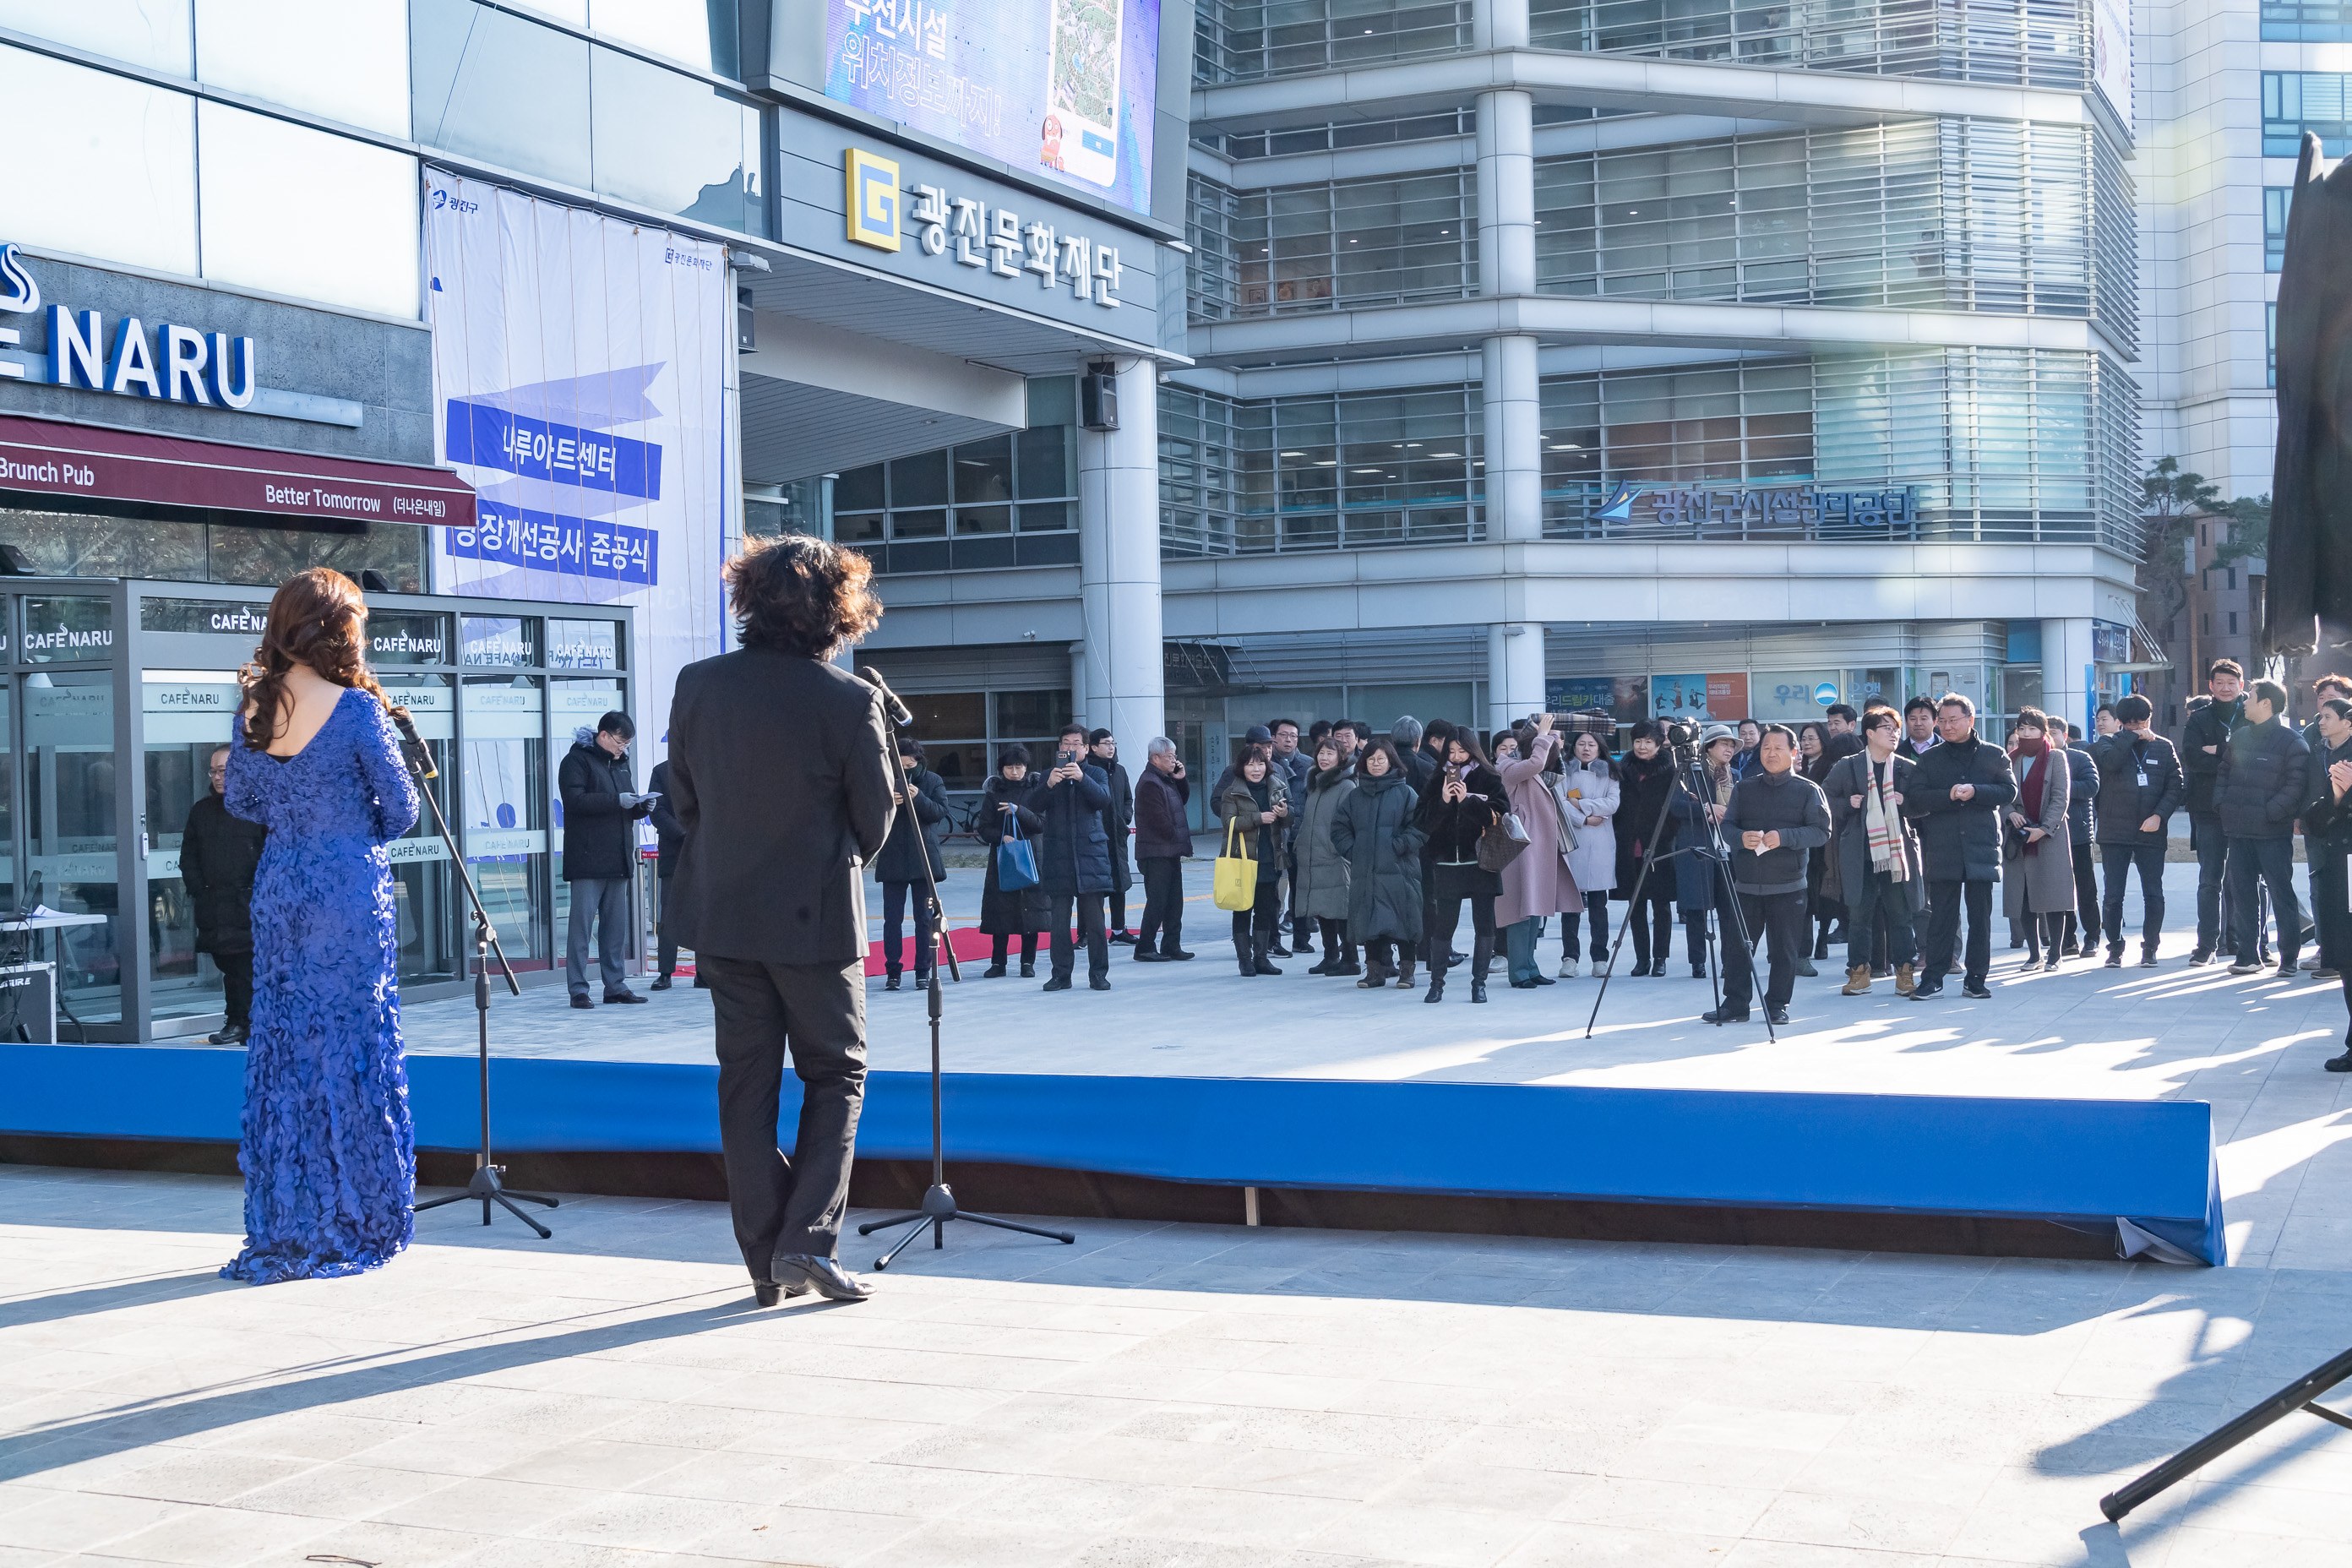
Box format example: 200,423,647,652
668,534,894,1307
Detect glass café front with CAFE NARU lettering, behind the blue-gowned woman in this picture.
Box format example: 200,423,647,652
0,575,637,1042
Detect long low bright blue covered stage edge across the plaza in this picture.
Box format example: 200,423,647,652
0,1043,2225,1265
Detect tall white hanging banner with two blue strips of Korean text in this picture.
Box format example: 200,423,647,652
426,169,736,783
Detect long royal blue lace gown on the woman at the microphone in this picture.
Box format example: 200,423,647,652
221,689,416,1283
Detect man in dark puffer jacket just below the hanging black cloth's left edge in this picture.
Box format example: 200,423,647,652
2213,679,2312,980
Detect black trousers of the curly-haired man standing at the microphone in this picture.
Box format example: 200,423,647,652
715,955,866,1279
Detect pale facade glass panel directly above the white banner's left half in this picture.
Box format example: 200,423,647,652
409,0,588,188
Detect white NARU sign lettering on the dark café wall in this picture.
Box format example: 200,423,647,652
0,244,259,409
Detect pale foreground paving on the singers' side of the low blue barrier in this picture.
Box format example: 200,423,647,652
0,1166,2352,1568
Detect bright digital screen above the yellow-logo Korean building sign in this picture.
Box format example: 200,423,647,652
825,0,1160,214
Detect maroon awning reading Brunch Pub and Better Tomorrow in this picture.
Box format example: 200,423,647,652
0,416,473,529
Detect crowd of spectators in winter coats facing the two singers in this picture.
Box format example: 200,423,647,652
877,661,2352,1070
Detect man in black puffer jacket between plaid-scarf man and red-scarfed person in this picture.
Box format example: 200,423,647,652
1903,691,2018,1001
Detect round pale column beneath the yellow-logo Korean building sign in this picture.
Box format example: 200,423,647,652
1070,360,1167,771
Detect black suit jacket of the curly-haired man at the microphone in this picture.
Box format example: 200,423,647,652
668,646,894,964
